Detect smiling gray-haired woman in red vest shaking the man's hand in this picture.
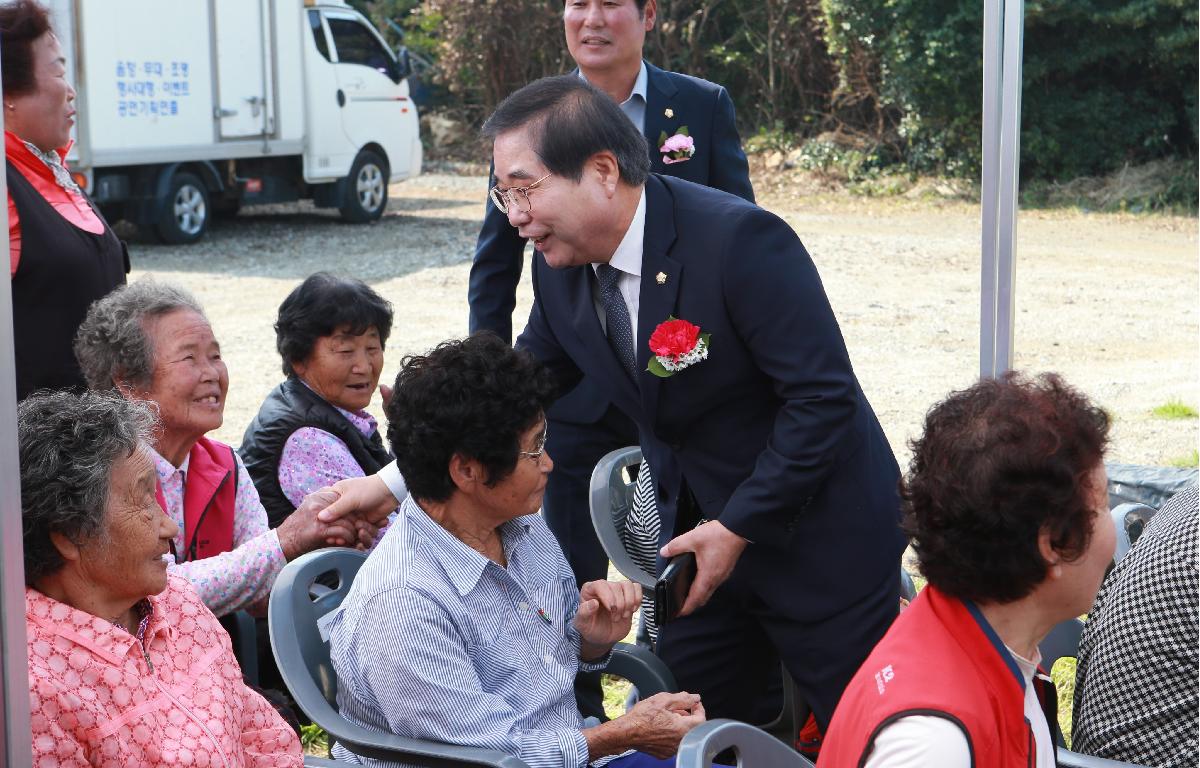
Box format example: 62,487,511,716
74,280,355,616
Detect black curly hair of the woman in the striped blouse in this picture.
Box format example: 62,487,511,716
384,331,556,502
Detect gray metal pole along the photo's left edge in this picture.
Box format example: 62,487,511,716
0,46,34,768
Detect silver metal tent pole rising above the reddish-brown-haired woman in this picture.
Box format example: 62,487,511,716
979,0,1025,376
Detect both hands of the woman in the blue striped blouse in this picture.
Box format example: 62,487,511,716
575,581,704,761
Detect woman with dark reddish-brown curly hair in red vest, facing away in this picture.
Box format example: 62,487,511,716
817,374,1115,768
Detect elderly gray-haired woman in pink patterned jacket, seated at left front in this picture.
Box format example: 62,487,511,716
18,392,304,768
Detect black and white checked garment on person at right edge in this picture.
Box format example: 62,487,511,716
1072,485,1200,768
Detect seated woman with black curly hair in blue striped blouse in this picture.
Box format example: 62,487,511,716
330,334,704,768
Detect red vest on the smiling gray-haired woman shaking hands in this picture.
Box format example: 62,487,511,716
155,437,238,563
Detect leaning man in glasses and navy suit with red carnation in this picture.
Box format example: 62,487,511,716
484,76,905,727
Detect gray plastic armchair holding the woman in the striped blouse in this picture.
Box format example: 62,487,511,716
266,547,676,768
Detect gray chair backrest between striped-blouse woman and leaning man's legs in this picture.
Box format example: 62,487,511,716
588,445,658,589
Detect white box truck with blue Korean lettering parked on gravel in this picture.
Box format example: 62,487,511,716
49,0,421,242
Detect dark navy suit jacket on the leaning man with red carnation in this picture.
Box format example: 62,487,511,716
517,175,904,619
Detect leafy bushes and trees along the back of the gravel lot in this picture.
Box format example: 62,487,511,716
352,0,1198,186
